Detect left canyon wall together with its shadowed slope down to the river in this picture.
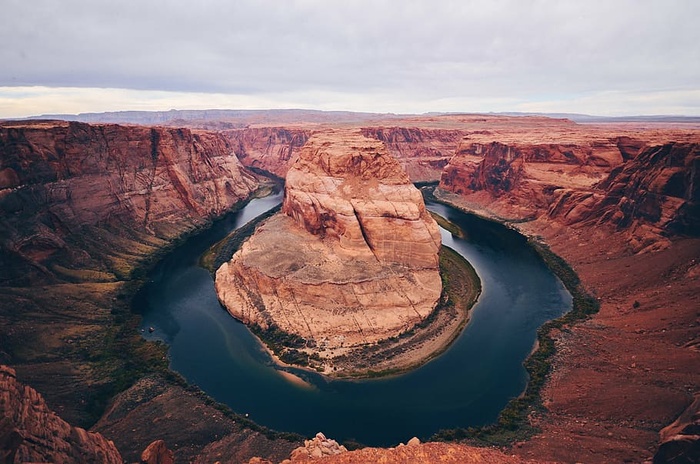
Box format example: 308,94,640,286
0,121,257,436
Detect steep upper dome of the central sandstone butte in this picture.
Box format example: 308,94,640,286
282,130,440,269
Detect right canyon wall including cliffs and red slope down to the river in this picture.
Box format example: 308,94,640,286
436,124,700,462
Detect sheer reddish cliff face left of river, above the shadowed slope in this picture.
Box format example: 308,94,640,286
0,122,256,285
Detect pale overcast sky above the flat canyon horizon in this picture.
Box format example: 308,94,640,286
0,0,700,118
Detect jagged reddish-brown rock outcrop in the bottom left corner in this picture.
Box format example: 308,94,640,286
0,365,122,464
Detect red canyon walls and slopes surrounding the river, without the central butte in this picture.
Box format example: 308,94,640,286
0,115,700,462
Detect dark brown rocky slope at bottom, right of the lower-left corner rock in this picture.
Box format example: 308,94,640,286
92,375,303,464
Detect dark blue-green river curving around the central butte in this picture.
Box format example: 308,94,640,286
134,195,571,446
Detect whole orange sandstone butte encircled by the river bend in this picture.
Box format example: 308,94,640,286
216,131,442,372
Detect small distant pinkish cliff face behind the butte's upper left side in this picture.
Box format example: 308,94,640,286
223,127,311,177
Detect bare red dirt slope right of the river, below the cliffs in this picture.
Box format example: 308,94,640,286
512,219,700,462
